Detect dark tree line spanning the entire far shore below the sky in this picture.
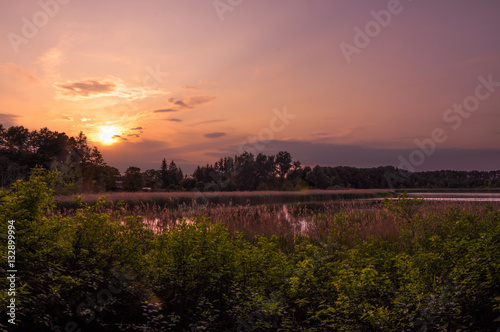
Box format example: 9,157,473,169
0,124,500,194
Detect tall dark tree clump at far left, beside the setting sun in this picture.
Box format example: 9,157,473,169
0,124,120,194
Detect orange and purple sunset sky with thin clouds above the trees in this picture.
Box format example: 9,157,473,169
0,0,500,173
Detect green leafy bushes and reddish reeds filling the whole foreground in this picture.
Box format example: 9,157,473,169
0,174,500,331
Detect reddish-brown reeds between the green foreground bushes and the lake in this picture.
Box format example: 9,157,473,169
54,195,500,250
